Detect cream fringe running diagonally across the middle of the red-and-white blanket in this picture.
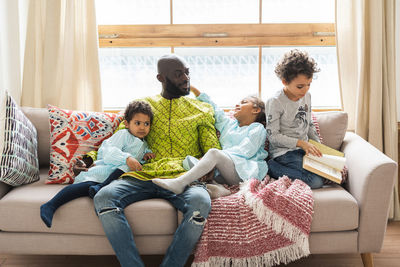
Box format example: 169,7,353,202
239,180,309,250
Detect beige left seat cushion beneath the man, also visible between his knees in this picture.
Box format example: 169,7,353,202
0,169,177,235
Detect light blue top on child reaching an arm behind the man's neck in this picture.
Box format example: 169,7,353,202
197,93,268,181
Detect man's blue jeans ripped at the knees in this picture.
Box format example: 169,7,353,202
94,178,211,267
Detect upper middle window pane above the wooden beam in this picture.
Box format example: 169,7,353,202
172,0,259,24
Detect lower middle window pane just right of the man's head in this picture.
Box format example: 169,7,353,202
175,47,258,108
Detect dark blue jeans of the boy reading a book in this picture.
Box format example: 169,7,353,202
268,149,324,189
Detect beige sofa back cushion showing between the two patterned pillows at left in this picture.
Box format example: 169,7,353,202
22,107,50,167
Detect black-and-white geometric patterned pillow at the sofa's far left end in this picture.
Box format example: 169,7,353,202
0,90,39,186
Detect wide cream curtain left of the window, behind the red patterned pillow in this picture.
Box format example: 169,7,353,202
21,0,102,111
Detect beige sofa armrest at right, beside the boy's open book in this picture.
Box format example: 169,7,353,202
341,132,397,253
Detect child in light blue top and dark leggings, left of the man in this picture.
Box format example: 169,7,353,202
40,101,155,227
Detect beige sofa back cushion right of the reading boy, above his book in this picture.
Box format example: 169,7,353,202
315,111,348,150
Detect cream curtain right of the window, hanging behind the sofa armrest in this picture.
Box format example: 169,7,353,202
336,0,400,220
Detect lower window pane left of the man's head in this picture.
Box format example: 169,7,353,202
99,48,171,109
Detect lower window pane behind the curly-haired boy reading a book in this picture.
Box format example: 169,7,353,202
261,47,341,108
